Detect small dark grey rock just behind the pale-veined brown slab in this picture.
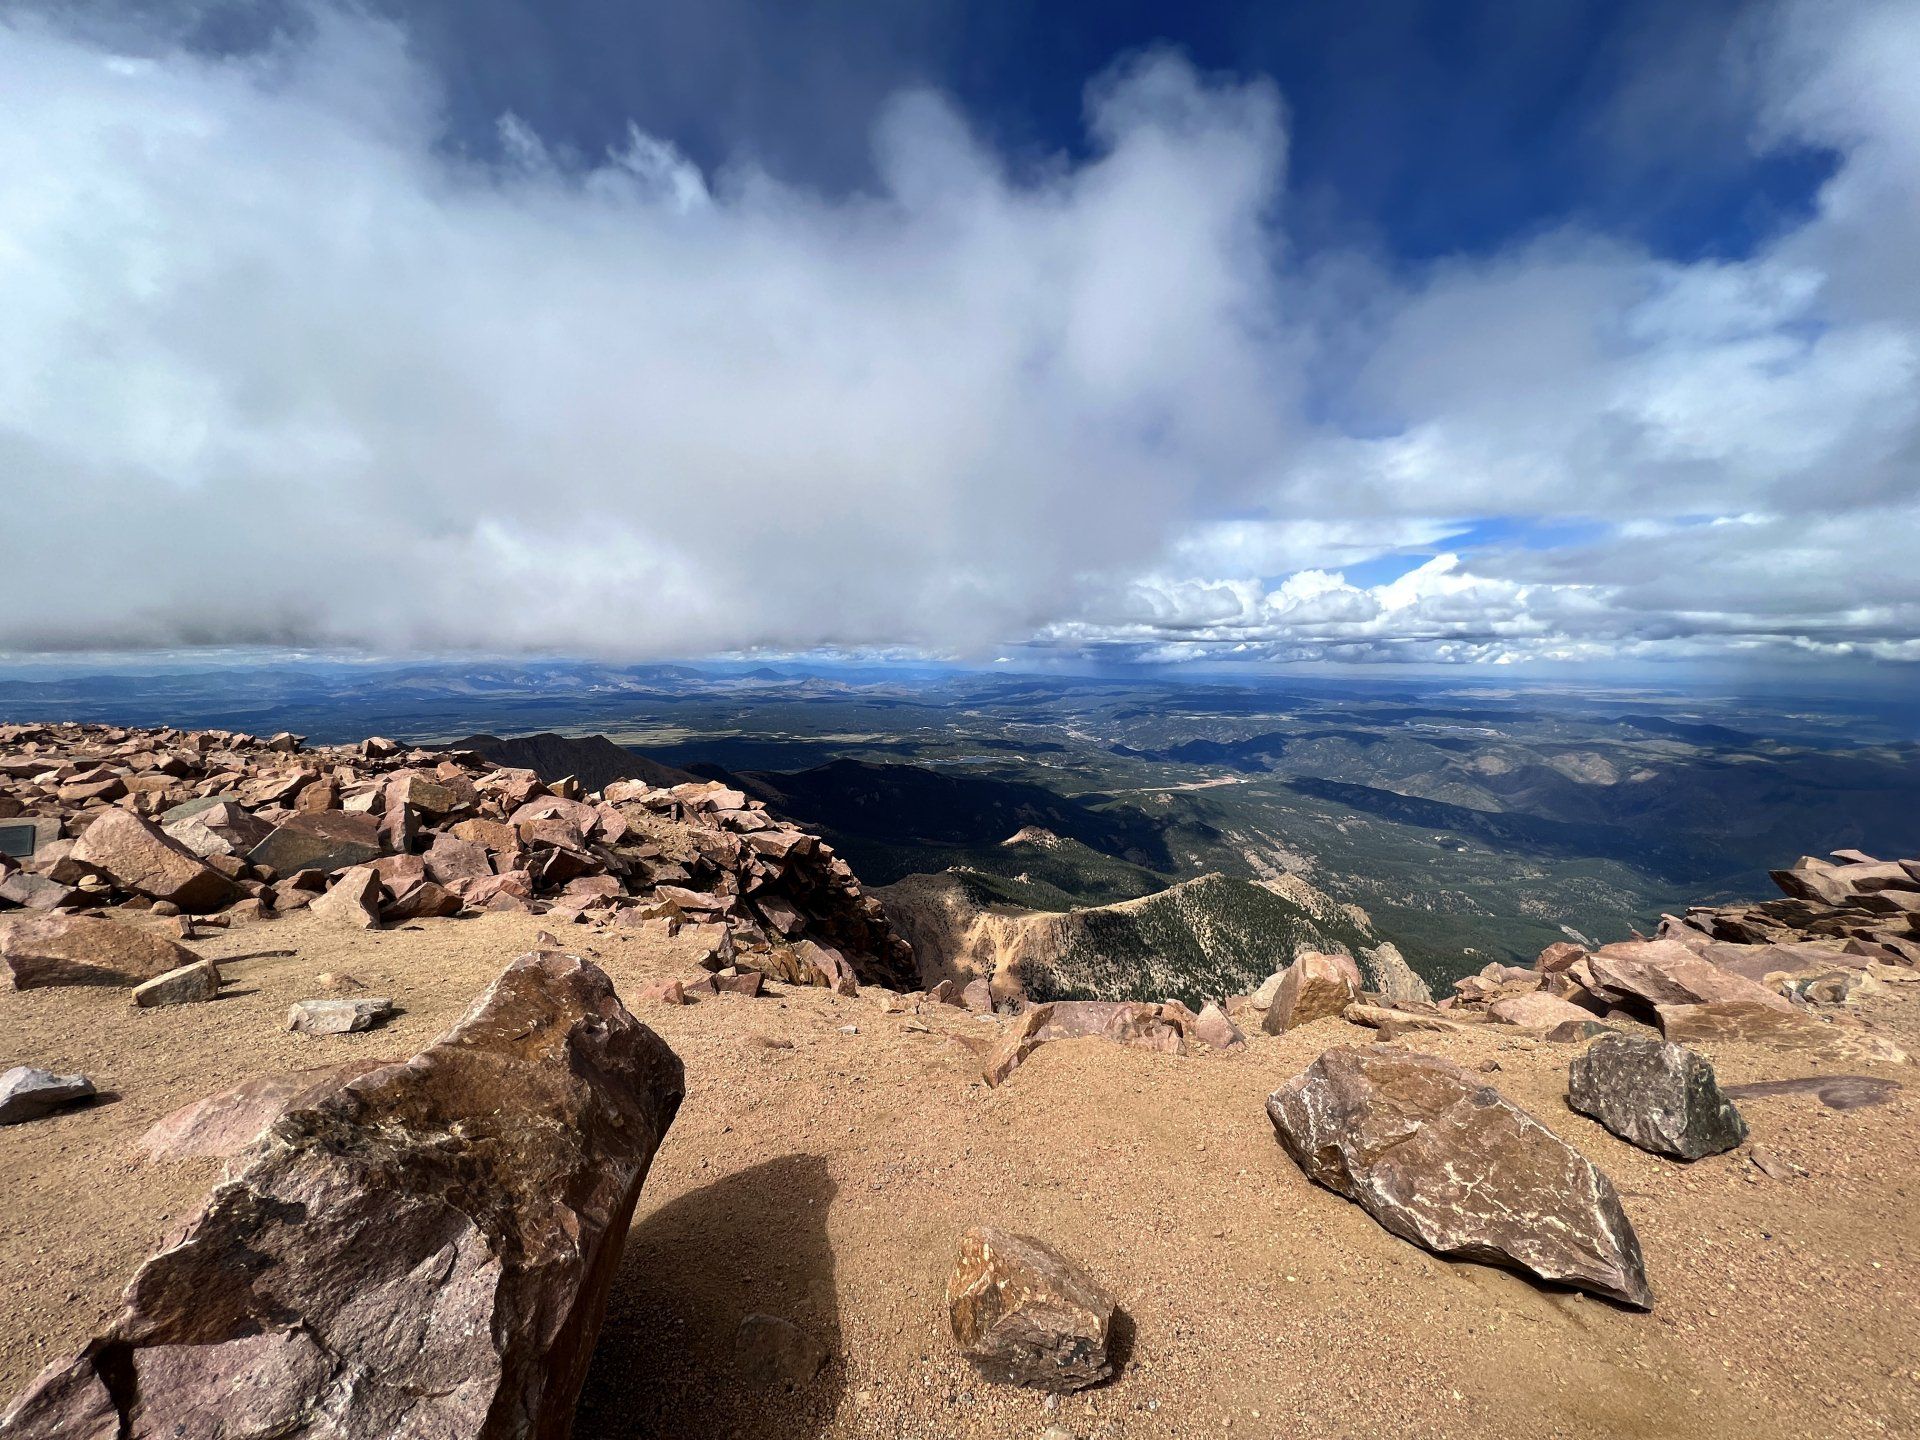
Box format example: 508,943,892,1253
1567,1035,1747,1160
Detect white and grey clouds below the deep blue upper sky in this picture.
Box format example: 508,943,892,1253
0,4,1920,662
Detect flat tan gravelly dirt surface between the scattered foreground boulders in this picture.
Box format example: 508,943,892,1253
0,916,1920,1440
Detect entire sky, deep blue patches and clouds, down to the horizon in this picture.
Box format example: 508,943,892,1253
0,0,1920,676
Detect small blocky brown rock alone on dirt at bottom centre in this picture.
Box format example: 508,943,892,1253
947,1225,1116,1392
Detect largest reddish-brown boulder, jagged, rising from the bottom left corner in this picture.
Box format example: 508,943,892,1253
0,954,684,1440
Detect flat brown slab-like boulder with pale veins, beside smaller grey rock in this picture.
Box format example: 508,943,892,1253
1267,1044,1653,1308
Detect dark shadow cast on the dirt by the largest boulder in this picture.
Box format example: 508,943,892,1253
574,1154,847,1440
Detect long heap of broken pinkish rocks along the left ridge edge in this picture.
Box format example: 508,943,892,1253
0,724,916,989
